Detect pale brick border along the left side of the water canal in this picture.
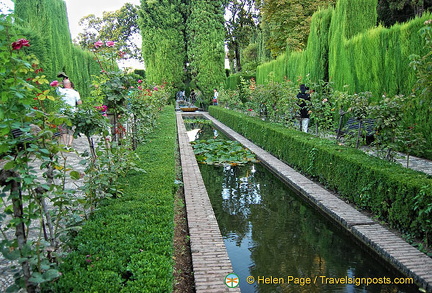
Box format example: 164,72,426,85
177,113,240,293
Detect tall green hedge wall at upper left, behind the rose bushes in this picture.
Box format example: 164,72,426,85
14,0,100,96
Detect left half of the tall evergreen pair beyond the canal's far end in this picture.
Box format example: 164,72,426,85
139,0,187,88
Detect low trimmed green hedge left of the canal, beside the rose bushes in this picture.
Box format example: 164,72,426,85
53,107,177,293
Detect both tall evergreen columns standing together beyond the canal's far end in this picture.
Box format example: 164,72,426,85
139,0,225,99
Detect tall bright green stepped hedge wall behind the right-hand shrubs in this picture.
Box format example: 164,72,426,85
257,0,431,97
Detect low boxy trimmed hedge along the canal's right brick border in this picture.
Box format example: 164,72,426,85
209,107,432,241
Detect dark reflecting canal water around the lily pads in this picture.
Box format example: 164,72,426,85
186,117,419,293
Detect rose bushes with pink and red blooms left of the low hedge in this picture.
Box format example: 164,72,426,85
0,15,170,292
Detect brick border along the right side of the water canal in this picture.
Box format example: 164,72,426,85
195,113,432,292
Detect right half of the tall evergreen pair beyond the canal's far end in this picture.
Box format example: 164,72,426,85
187,0,226,98
